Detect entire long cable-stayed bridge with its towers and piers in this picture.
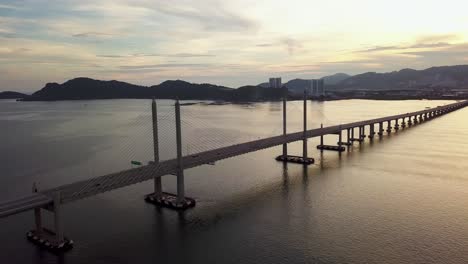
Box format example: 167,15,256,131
0,95,468,251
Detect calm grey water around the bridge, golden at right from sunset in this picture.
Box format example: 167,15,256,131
0,100,468,263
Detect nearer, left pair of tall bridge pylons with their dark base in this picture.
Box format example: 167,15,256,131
145,100,195,210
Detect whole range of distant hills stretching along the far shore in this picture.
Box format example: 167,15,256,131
5,65,468,101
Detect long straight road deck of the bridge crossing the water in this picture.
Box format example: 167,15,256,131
0,101,468,217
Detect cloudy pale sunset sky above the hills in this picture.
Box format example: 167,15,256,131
0,0,468,92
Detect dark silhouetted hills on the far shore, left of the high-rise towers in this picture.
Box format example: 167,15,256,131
23,77,284,101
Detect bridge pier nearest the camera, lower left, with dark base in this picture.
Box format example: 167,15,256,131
26,190,73,252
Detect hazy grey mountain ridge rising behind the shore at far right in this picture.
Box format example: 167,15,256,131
328,65,468,90
